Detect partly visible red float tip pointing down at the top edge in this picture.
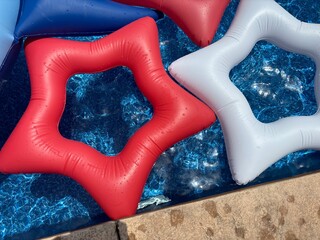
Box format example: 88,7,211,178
115,0,230,47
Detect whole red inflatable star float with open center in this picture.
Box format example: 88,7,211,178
0,17,215,219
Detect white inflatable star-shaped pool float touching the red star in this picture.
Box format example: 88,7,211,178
169,0,320,184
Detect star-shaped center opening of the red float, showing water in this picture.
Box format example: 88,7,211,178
59,67,153,155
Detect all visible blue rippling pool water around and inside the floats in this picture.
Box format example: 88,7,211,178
0,0,320,239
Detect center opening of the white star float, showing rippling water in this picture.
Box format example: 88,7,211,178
230,41,317,123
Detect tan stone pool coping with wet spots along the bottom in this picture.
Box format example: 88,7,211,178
45,172,320,240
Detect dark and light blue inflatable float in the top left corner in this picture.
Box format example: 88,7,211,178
0,0,162,79
